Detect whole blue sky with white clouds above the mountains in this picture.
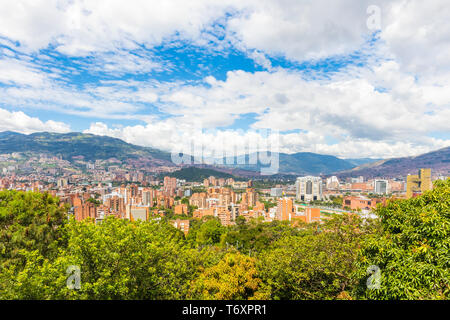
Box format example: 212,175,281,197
0,0,450,158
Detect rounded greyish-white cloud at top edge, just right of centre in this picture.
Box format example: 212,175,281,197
228,0,372,61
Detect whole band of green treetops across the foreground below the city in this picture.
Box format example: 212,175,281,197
0,180,450,299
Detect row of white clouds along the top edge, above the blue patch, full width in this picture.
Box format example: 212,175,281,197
0,0,450,72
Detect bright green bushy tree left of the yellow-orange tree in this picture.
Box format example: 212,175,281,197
0,217,220,300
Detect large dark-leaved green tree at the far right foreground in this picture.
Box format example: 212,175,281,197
355,179,450,299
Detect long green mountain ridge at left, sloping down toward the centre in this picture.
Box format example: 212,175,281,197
0,131,172,164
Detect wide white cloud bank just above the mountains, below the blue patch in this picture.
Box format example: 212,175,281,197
0,55,450,157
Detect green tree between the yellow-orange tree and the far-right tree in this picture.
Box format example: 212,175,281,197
257,215,374,300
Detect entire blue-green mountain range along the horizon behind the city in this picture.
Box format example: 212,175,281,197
0,131,444,177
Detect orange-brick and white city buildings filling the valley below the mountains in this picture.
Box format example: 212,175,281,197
0,157,444,238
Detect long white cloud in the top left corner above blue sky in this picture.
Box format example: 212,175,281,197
0,0,234,56
